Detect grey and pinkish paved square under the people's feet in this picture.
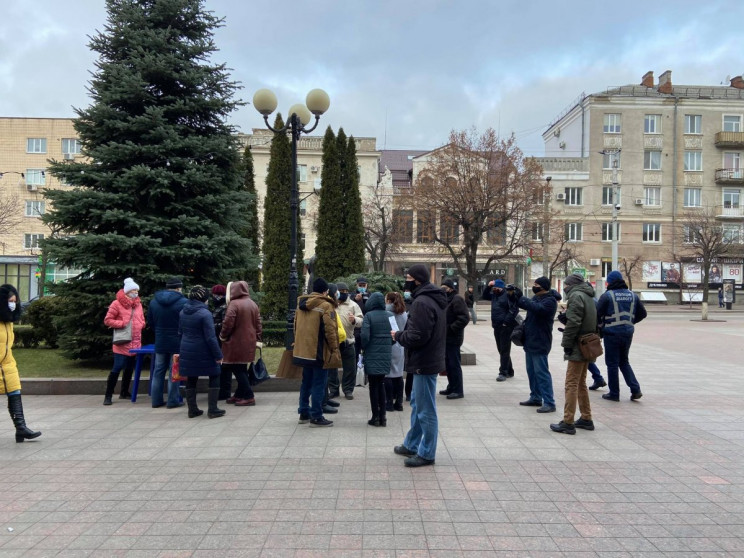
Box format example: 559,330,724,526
0,310,744,558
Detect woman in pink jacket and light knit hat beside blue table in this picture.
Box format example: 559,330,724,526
103,277,145,405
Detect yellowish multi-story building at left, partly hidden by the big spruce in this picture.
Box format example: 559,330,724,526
0,118,80,300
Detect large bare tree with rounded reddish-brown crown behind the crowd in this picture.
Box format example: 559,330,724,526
405,128,542,284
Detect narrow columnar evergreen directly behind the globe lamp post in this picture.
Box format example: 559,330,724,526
261,115,299,320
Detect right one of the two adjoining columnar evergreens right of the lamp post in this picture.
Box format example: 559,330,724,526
339,137,367,273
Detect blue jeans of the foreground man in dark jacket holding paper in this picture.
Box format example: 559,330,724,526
403,374,439,460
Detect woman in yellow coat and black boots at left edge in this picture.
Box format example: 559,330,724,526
0,285,41,442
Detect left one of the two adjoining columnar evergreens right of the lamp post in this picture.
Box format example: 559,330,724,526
315,126,346,281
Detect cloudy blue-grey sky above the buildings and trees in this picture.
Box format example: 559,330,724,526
0,0,744,155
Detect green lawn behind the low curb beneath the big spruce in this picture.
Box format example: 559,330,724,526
13,347,284,379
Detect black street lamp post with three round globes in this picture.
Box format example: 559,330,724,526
253,89,331,351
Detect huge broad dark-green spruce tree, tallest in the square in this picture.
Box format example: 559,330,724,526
44,0,256,358
